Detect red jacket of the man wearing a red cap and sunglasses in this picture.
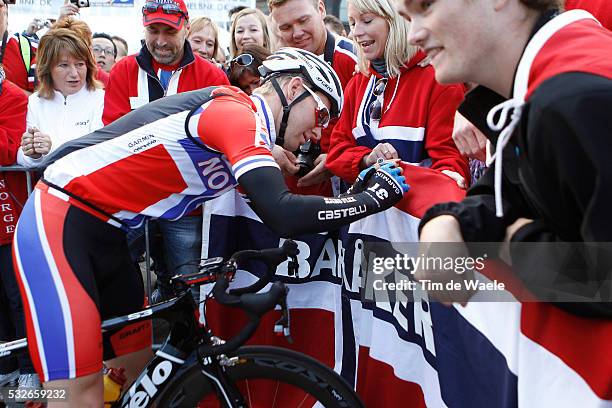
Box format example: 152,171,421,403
102,41,229,125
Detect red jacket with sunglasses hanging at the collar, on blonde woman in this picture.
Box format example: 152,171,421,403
327,52,470,184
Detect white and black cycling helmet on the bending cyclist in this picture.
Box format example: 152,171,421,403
259,47,343,118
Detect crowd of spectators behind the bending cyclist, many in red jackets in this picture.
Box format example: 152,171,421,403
0,0,612,402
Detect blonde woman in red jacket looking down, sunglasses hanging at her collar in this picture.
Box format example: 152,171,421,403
327,0,469,194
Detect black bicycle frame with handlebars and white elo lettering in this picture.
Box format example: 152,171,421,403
0,241,297,408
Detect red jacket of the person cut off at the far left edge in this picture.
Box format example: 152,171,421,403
0,81,28,245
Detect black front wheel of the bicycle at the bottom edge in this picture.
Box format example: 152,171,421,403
155,346,363,408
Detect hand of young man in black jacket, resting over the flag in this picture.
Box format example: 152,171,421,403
414,215,475,306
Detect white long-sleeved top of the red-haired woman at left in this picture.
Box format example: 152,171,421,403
17,86,104,166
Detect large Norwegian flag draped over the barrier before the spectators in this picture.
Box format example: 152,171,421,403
204,163,612,408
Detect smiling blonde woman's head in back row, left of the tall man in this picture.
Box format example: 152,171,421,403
230,8,271,58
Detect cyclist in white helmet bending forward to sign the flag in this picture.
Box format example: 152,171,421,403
13,48,408,407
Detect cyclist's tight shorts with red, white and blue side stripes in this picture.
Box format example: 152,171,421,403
13,183,151,381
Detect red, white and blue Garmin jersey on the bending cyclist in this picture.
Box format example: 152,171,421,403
44,86,278,228
